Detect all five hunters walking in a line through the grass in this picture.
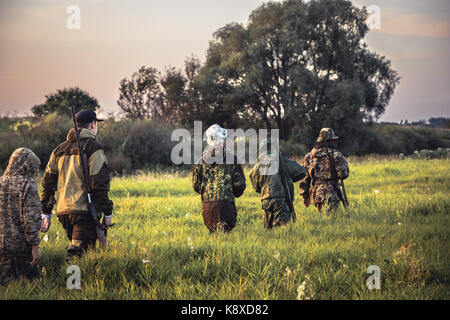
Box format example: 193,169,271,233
0,110,349,284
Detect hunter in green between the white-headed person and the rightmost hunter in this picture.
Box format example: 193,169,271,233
250,140,306,229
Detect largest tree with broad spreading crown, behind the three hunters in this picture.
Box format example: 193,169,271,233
197,0,399,141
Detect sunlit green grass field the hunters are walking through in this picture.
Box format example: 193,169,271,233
0,160,450,299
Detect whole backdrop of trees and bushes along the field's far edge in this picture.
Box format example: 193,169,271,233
0,0,449,172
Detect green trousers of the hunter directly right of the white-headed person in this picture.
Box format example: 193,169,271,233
261,198,291,229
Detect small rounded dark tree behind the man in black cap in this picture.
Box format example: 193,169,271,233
31,87,100,117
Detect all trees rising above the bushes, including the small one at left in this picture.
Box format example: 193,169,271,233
29,0,400,150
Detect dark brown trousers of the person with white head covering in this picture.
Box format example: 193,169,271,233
202,201,237,232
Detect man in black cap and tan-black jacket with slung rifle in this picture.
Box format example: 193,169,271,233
41,110,113,259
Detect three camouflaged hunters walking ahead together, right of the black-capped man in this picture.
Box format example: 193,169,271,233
192,124,349,232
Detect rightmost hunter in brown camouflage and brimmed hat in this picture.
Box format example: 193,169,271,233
300,128,349,211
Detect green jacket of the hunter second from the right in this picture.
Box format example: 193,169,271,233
250,154,306,200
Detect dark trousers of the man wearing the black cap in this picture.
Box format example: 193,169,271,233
58,214,97,257
